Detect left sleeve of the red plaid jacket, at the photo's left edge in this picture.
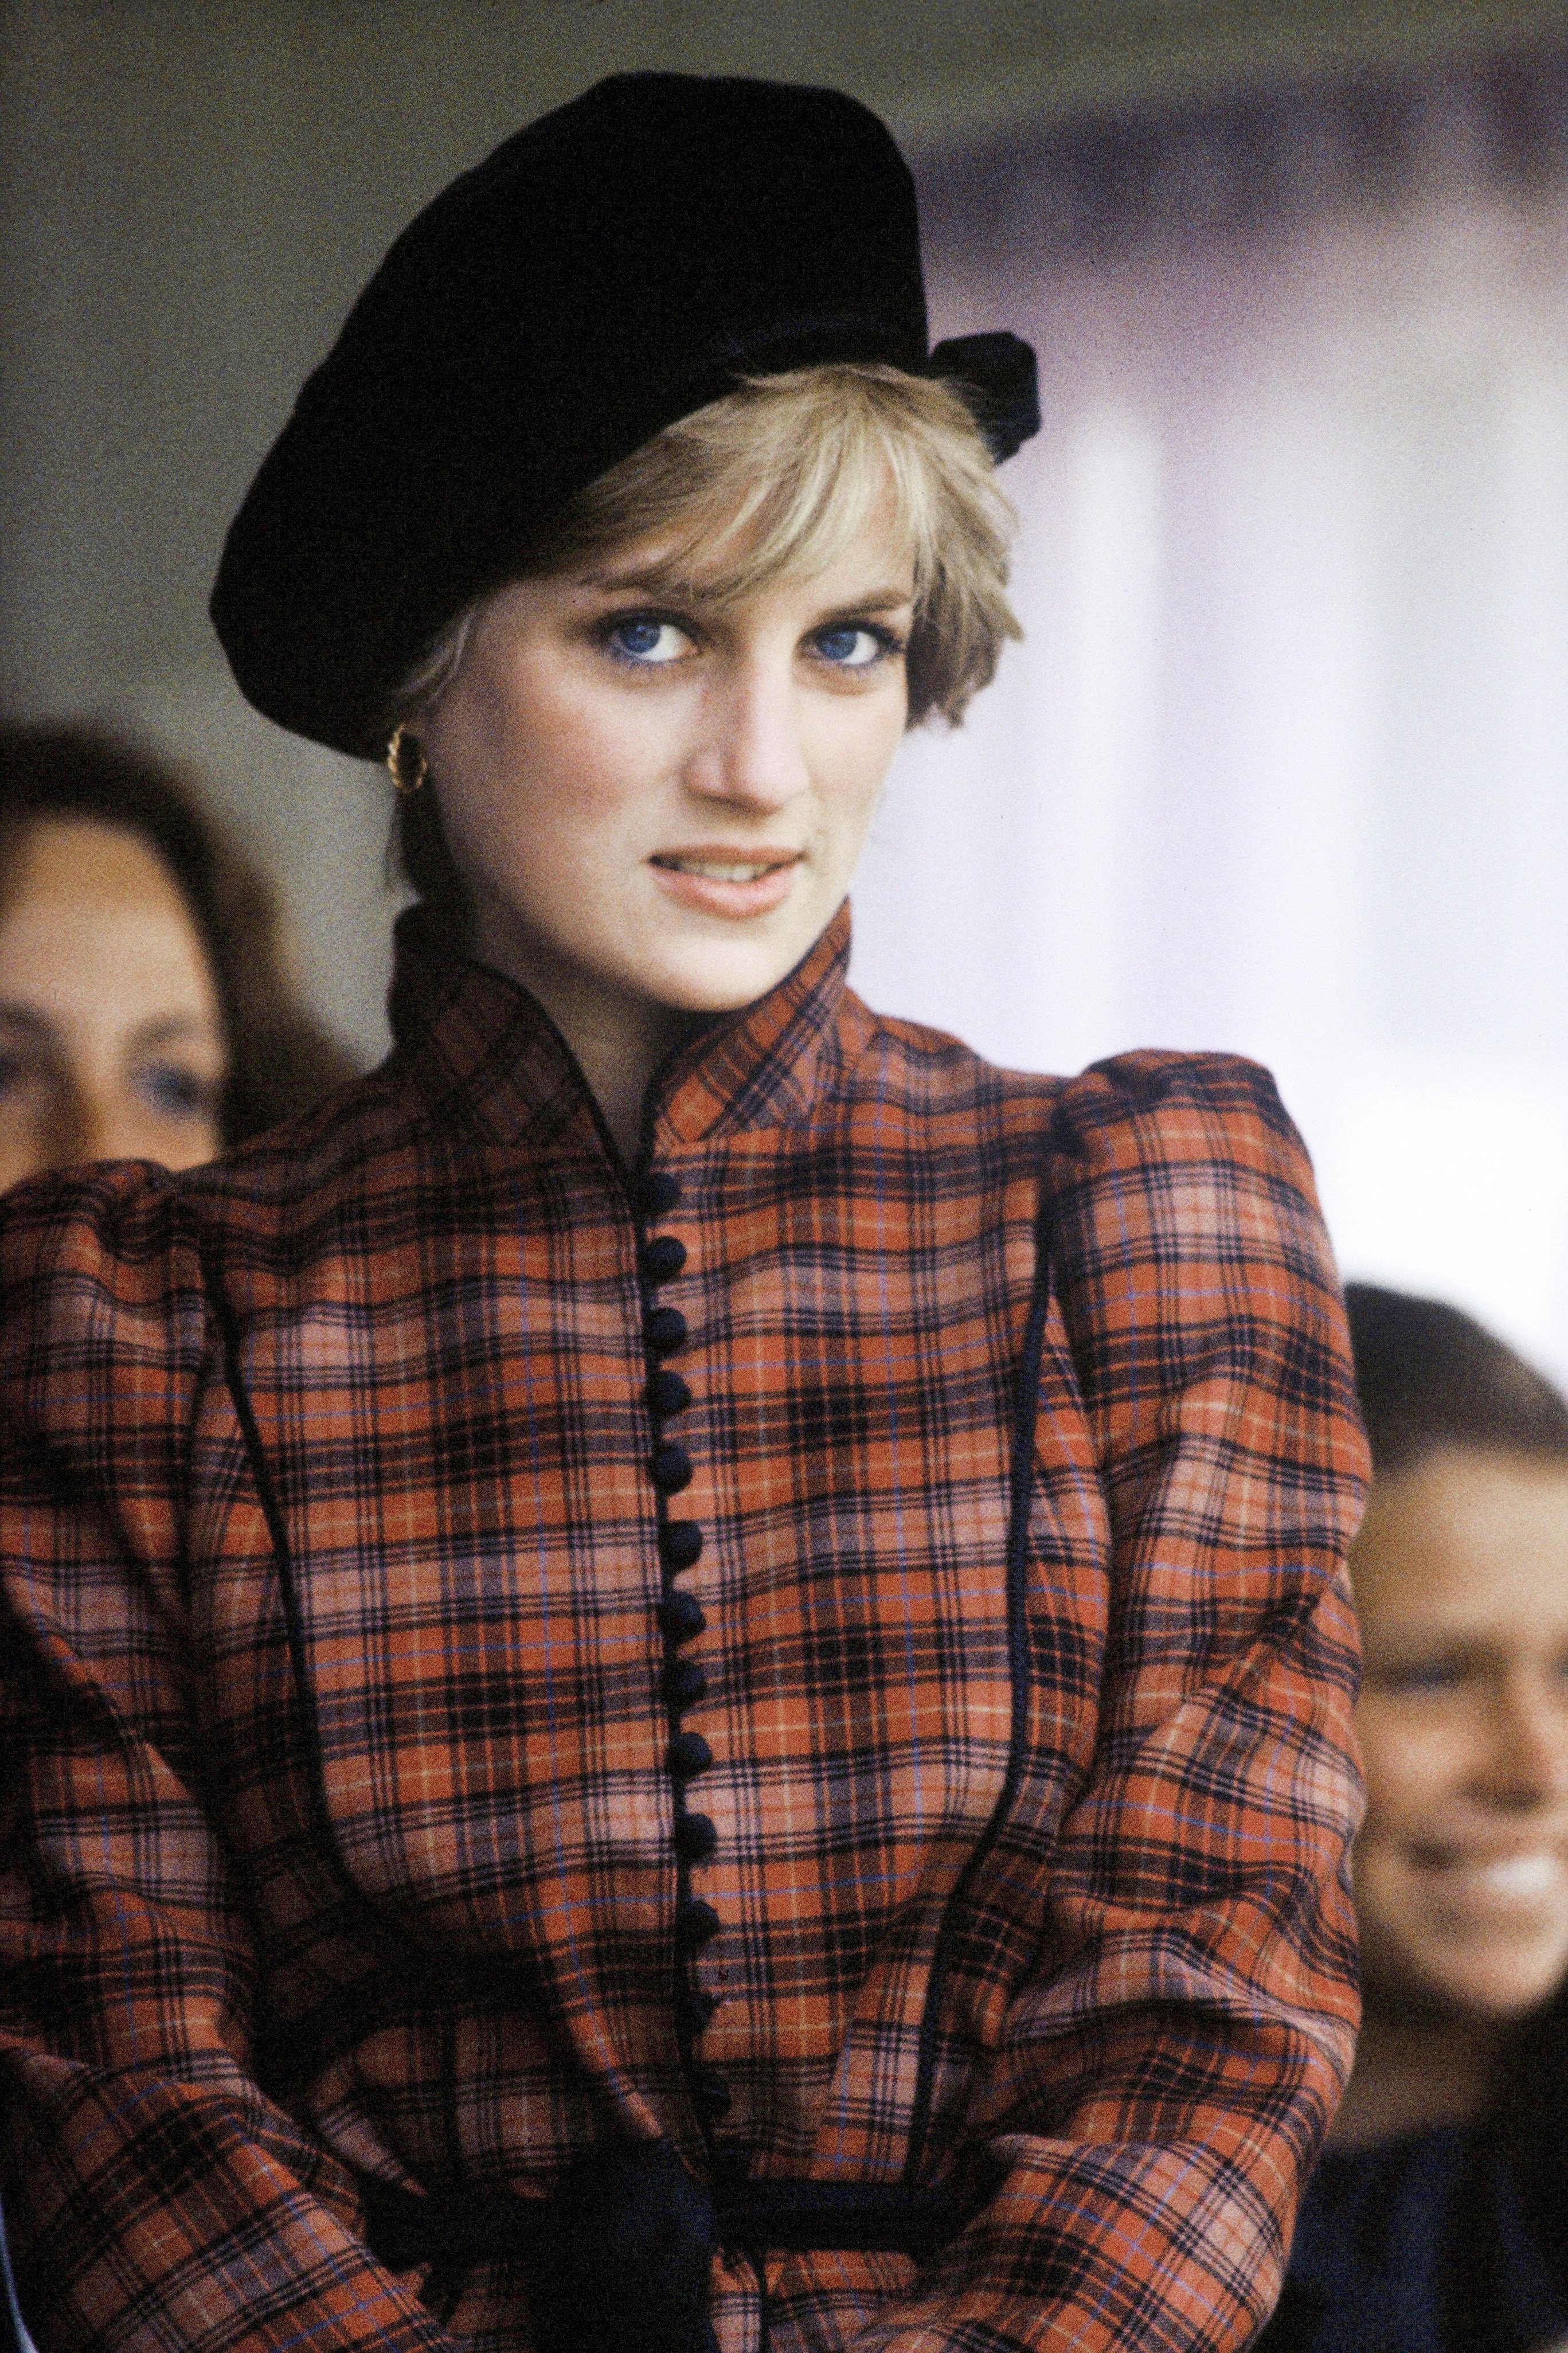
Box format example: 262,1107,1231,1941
0,1170,447,2353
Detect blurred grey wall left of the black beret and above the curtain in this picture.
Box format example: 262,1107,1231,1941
0,0,1566,1054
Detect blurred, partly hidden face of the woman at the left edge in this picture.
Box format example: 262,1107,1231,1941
0,816,228,1186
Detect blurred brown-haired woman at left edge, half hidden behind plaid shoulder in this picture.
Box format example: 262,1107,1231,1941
0,727,353,1186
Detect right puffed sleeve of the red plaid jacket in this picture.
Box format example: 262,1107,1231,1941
857,1054,1366,2353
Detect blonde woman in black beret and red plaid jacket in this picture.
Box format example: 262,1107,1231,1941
0,75,1361,2353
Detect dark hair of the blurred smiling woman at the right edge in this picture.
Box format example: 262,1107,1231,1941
1344,1283,1568,2346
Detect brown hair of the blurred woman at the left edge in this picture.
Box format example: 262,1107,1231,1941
0,727,355,1146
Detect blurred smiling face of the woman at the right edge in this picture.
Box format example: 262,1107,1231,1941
1351,1452,1568,2021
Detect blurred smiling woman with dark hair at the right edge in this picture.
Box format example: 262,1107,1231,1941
1262,1285,1568,2353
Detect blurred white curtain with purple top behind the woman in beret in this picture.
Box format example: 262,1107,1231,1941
855,52,1568,1377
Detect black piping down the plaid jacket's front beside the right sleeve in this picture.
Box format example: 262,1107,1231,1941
904,1117,1057,2186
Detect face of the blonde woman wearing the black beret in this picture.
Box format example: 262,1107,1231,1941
417,501,913,1038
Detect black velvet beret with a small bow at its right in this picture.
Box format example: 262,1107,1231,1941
212,73,1038,757
